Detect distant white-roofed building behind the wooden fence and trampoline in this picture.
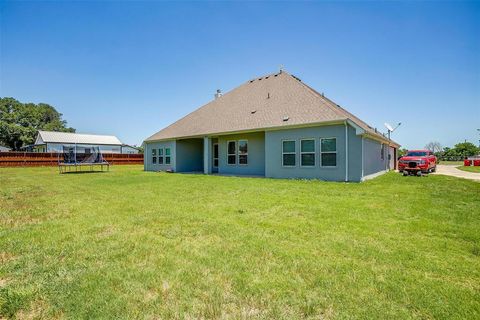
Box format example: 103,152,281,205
32,131,139,154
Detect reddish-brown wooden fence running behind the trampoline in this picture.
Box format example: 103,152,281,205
0,152,143,167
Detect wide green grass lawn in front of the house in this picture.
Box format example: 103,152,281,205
0,166,480,319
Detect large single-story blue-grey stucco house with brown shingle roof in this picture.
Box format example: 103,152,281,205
144,71,399,181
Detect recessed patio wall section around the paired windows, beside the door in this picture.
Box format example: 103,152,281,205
217,132,265,176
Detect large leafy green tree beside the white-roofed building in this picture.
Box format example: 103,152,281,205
0,98,75,150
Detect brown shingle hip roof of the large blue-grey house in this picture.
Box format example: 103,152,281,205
145,71,400,146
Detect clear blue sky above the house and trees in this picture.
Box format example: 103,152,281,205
0,1,480,148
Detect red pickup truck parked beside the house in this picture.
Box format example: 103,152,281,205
398,150,437,176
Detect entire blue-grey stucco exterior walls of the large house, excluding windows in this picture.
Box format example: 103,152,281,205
144,124,388,181
